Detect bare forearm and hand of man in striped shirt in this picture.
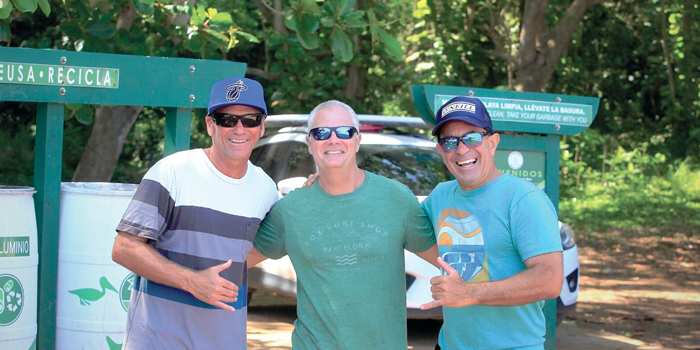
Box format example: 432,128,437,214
112,232,238,311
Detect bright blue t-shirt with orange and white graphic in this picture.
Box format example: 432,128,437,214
423,174,562,350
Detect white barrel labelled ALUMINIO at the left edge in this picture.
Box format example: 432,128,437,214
0,186,39,350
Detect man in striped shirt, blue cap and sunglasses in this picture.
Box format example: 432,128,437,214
112,77,277,350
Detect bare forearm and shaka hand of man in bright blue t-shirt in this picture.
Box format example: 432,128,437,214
421,252,564,310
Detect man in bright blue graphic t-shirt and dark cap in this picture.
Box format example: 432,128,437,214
421,96,563,350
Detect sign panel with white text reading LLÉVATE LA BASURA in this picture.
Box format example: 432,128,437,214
435,95,593,127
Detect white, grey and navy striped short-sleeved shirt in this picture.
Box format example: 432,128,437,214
117,149,277,350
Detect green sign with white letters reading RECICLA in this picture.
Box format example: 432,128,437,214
0,62,119,89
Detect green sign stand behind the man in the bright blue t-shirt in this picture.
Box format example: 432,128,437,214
411,85,600,350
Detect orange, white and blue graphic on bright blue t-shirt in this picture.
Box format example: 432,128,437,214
437,209,489,282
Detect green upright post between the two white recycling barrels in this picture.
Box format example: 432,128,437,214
34,103,64,350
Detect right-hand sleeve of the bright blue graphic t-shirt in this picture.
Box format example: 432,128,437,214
510,190,562,261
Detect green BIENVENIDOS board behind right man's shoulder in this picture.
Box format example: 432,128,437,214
494,149,545,191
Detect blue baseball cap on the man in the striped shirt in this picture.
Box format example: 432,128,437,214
207,77,267,115
